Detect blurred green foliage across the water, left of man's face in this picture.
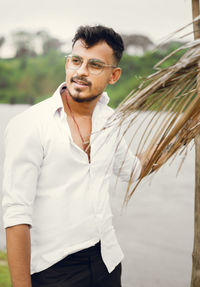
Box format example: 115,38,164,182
0,51,65,104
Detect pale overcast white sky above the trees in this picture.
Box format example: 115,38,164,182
0,0,192,55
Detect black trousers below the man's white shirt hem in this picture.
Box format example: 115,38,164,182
31,243,121,287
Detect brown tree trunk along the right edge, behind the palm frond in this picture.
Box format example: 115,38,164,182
190,0,200,287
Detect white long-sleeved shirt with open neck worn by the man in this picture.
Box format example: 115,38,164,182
2,84,141,274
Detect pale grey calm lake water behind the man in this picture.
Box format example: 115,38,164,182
0,104,194,287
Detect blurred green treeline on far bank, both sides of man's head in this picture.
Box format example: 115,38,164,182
0,42,184,107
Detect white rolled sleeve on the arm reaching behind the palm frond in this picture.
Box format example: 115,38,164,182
113,139,142,182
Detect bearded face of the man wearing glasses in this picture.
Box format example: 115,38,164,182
66,40,121,102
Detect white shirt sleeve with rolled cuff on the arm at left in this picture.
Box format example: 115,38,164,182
2,115,43,228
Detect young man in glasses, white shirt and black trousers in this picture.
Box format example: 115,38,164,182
3,26,141,287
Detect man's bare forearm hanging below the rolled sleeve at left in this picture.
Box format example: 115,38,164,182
6,224,32,287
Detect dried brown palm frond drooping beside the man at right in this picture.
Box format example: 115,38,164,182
106,20,200,204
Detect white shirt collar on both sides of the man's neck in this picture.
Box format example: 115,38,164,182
51,82,110,113
